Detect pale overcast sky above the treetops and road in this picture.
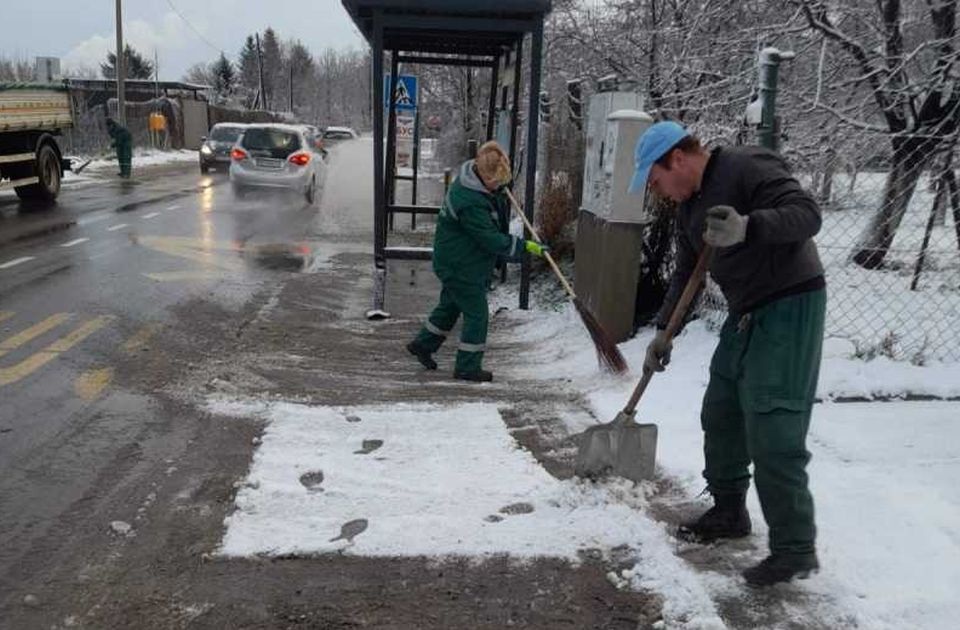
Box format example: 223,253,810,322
0,0,366,80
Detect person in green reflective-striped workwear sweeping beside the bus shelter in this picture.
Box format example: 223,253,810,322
407,142,549,382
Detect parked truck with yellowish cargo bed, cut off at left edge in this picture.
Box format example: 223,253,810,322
0,83,74,202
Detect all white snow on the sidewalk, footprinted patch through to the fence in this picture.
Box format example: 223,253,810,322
209,296,960,629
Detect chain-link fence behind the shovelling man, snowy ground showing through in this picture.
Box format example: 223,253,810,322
798,131,960,364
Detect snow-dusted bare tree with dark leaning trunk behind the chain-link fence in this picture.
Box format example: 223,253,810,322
791,0,960,269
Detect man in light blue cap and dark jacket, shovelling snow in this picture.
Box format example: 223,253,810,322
630,121,826,586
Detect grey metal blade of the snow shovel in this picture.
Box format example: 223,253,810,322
574,411,657,481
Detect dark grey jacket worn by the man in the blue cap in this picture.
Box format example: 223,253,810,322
657,147,823,327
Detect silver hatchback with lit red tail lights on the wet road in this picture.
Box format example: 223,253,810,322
230,124,326,203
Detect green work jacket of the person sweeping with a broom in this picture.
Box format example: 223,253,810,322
433,160,524,287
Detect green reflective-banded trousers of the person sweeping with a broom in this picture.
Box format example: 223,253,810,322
416,282,490,373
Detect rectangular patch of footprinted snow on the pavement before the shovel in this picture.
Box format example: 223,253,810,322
210,400,723,629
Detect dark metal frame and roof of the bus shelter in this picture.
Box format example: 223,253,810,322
342,0,551,319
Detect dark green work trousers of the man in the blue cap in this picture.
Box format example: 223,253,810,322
700,289,826,553
